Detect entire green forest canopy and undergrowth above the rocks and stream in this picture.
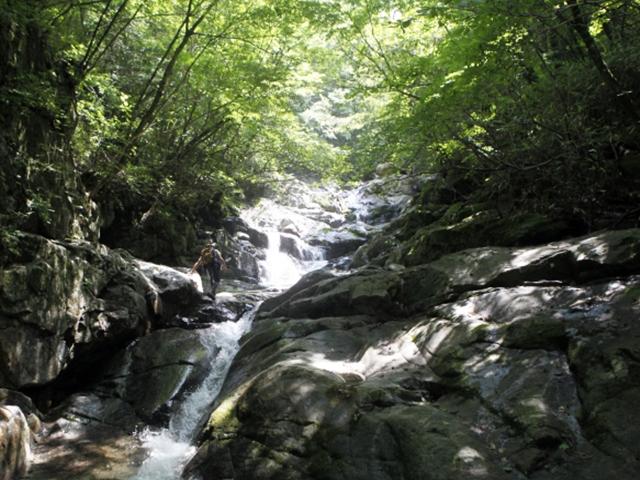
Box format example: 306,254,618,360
0,0,640,248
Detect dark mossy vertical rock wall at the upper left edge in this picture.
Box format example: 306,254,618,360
0,0,98,242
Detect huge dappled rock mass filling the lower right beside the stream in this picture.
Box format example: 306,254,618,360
185,230,640,480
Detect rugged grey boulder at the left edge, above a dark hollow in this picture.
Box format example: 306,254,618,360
0,234,150,388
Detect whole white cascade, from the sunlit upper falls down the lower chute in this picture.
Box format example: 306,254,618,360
127,178,408,480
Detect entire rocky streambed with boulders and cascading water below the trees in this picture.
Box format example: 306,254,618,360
0,173,640,480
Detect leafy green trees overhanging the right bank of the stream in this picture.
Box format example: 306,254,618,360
332,0,640,228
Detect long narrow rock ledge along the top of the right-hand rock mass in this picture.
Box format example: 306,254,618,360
261,230,640,318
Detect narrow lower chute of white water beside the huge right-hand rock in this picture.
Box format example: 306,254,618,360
133,306,257,480
